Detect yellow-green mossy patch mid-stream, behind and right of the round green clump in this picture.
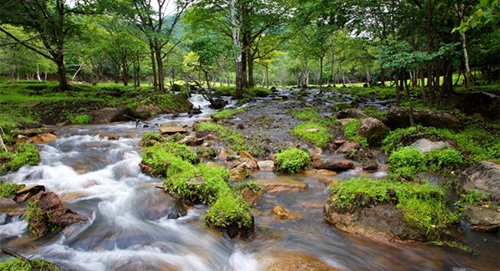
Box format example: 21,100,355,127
292,121,333,148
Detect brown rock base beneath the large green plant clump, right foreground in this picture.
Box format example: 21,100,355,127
323,203,425,241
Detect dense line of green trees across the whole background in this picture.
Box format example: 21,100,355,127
0,0,500,98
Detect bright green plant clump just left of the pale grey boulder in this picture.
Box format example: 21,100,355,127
389,147,426,180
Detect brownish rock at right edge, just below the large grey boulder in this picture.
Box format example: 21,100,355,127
464,204,500,233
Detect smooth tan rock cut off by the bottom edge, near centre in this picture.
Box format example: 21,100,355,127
265,251,340,271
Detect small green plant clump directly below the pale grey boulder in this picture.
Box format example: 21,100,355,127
427,148,464,171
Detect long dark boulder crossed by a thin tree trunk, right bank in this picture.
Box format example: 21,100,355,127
385,107,461,130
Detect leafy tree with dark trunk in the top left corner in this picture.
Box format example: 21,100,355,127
0,0,87,91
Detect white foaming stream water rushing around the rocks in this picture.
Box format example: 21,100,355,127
0,93,500,271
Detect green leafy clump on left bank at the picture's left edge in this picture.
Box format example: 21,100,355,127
0,143,40,172
